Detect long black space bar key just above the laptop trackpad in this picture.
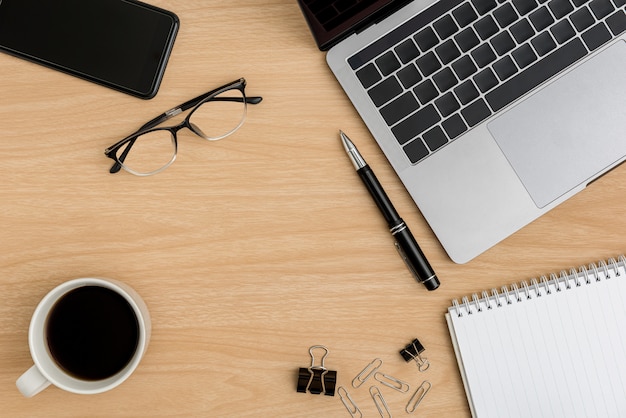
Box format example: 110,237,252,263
485,38,587,112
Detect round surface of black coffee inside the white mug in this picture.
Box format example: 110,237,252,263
46,286,139,380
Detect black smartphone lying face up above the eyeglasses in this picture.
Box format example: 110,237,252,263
0,0,179,99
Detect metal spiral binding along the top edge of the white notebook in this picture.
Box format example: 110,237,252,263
452,255,626,317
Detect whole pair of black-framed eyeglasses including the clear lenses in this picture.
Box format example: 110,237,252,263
104,78,263,176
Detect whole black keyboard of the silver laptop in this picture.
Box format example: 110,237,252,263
348,0,626,163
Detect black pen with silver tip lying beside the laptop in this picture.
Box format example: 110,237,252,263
339,131,439,290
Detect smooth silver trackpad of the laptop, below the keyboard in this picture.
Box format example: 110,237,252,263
488,41,626,208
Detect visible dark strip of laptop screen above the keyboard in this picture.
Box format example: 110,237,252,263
298,0,409,51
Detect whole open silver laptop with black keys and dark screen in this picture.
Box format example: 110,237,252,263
298,0,626,263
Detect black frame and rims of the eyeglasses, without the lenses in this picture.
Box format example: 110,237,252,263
104,77,263,176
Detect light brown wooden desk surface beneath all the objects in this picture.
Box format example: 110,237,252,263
0,0,626,417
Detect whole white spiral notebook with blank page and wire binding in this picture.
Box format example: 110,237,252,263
446,256,626,418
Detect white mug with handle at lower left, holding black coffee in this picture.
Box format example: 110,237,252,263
16,278,152,397
